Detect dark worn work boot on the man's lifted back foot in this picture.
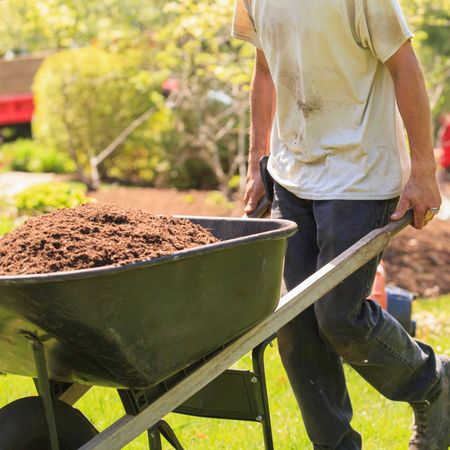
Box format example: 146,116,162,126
409,356,450,450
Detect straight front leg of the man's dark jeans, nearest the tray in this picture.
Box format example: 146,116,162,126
272,185,361,450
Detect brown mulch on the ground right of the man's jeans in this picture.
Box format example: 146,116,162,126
384,219,450,297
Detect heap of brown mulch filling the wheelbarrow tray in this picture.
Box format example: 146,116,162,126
0,203,218,275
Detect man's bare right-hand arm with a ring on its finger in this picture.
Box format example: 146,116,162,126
386,41,441,229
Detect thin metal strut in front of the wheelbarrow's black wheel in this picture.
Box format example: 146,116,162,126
24,332,59,450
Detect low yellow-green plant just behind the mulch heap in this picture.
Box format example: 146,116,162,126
14,183,90,215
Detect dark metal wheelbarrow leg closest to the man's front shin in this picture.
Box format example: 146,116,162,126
252,335,276,450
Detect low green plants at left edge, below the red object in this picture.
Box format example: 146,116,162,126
0,139,75,173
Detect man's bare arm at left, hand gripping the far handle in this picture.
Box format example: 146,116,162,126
244,49,275,214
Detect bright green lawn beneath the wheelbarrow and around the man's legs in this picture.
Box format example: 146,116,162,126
0,295,450,450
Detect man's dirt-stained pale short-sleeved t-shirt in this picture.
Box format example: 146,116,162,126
232,0,412,200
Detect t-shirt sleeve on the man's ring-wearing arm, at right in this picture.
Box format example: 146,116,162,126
356,0,413,63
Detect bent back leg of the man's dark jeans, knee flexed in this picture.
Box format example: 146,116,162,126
314,199,439,402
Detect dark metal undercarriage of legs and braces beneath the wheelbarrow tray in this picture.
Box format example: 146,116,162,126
23,332,276,450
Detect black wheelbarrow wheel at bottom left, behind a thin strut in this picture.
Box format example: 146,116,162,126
0,397,98,450
